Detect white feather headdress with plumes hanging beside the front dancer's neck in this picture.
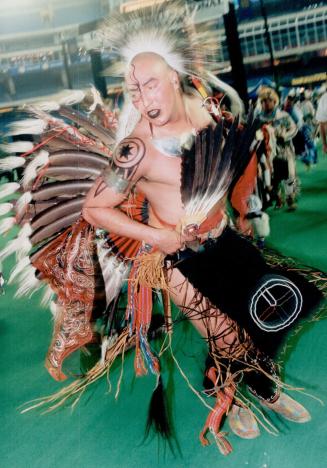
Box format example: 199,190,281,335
99,1,243,141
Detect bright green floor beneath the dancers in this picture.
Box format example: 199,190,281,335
0,152,327,468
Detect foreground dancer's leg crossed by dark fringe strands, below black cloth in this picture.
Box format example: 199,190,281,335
168,268,278,401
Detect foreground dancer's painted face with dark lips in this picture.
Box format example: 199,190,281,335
125,53,179,126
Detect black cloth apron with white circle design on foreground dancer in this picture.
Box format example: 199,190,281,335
167,227,321,399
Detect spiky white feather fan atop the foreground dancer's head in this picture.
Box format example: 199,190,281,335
99,1,218,76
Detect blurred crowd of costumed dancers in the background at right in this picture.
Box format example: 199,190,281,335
232,80,327,247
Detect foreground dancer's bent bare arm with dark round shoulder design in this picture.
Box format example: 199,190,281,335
83,137,182,253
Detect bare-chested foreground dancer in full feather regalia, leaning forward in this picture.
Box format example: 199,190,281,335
2,1,320,454
